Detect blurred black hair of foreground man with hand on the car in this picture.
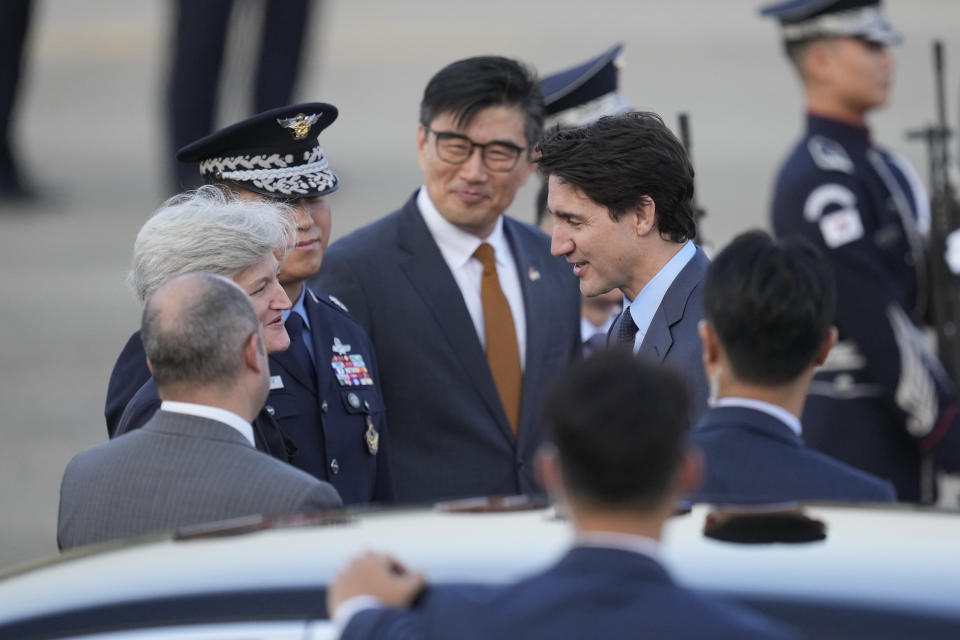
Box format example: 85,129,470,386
544,349,689,511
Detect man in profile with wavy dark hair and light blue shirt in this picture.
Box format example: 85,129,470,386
538,112,709,422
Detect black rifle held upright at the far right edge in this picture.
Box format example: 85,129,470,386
907,40,960,386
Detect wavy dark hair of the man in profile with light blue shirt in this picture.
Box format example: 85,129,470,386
537,111,697,242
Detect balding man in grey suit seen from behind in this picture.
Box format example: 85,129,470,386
57,273,341,549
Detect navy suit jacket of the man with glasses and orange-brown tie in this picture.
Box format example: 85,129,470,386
314,195,580,501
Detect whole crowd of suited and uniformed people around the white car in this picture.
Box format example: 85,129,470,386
58,0,960,638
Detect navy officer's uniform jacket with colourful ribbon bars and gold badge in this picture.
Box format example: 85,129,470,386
266,287,394,505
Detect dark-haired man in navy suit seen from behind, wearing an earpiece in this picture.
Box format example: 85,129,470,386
691,231,895,505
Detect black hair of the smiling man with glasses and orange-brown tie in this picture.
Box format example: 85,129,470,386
420,56,544,145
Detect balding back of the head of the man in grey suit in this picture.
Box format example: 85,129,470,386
140,273,262,392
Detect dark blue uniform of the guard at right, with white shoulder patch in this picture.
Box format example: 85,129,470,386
772,115,960,501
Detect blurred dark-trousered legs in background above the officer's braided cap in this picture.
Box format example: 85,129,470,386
166,0,314,192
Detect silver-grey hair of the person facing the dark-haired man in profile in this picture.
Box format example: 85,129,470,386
128,185,296,305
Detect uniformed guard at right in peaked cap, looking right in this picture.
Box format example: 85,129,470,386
762,0,960,503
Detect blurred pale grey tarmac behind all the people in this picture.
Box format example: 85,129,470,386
0,0,960,568
